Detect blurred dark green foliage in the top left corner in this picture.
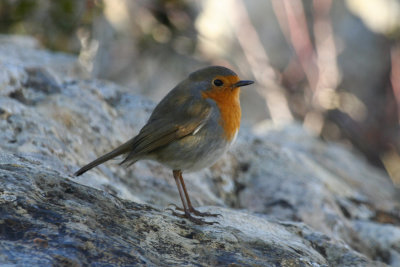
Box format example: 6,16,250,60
0,0,103,53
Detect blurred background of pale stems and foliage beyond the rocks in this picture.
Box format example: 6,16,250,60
0,0,400,186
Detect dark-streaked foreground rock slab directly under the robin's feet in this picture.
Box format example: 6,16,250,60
0,153,368,266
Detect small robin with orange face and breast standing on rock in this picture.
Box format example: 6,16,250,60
75,66,254,224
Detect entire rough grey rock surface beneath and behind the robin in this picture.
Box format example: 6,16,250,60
0,36,400,266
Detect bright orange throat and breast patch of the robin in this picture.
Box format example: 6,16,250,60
202,88,242,141
